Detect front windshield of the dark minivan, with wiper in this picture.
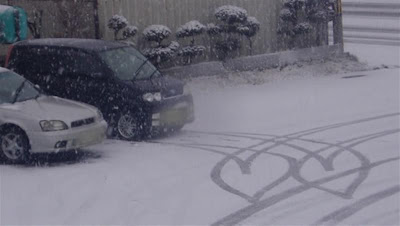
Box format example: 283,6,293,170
100,47,161,80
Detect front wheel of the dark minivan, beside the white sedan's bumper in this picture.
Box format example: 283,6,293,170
117,112,142,140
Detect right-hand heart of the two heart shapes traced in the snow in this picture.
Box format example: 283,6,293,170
293,146,370,199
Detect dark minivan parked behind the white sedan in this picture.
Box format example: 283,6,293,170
6,39,194,140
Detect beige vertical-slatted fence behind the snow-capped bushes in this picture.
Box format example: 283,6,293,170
99,0,281,54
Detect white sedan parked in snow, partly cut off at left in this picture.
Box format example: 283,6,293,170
0,67,107,163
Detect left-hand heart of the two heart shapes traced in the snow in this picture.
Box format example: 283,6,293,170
211,153,296,203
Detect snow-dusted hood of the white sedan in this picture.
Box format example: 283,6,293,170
1,96,97,125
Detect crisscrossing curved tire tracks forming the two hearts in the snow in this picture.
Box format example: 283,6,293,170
160,113,399,225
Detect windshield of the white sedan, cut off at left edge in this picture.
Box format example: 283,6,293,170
0,71,40,104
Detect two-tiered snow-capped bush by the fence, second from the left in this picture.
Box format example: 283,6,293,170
143,25,179,66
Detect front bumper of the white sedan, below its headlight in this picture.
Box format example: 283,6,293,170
28,120,108,153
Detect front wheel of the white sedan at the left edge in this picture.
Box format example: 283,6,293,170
0,127,30,164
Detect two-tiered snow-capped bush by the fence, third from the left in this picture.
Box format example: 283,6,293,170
176,20,206,64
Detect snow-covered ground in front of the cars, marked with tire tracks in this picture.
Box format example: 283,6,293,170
0,64,400,225
